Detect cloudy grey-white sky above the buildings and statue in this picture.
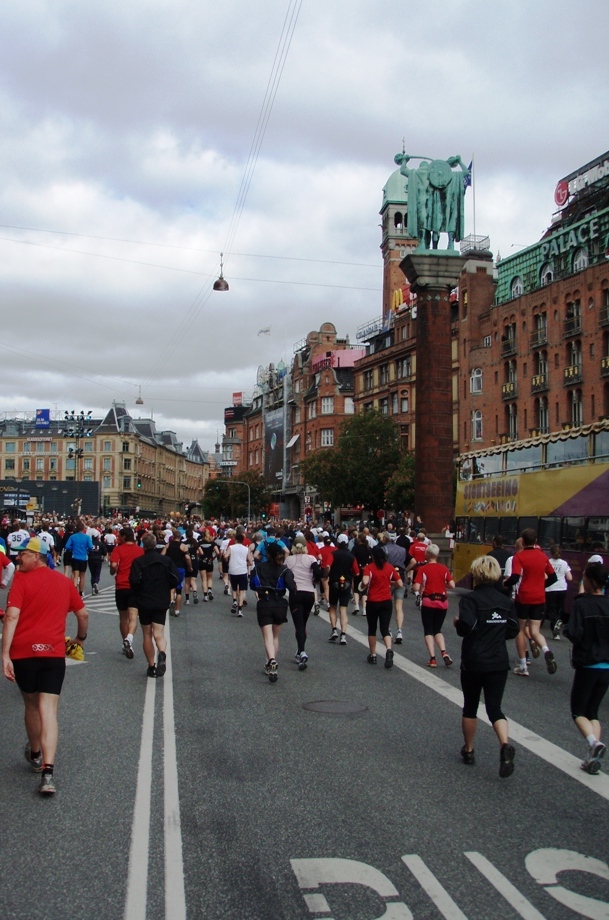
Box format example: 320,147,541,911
0,0,609,449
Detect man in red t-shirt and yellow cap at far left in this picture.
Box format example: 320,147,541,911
2,537,89,795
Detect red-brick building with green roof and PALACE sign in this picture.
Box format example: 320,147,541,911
458,147,609,452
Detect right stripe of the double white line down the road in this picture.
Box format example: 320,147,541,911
162,620,186,920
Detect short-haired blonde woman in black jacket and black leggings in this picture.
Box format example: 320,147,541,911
453,556,519,777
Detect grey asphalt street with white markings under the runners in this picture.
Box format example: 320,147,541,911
0,566,609,920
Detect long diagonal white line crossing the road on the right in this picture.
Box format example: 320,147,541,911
319,610,609,801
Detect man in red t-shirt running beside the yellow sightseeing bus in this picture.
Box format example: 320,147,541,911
505,528,557,677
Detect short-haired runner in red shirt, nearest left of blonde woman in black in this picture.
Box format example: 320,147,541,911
411,543,455,668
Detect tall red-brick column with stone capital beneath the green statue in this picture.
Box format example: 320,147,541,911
400,250,467,533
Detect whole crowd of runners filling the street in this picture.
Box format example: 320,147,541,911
0,518,609,793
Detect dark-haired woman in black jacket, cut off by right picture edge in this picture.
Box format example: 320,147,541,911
563,562,609,776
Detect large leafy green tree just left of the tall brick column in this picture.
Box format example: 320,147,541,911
302,412,400,512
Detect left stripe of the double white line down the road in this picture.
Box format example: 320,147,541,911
124,679,156,920
